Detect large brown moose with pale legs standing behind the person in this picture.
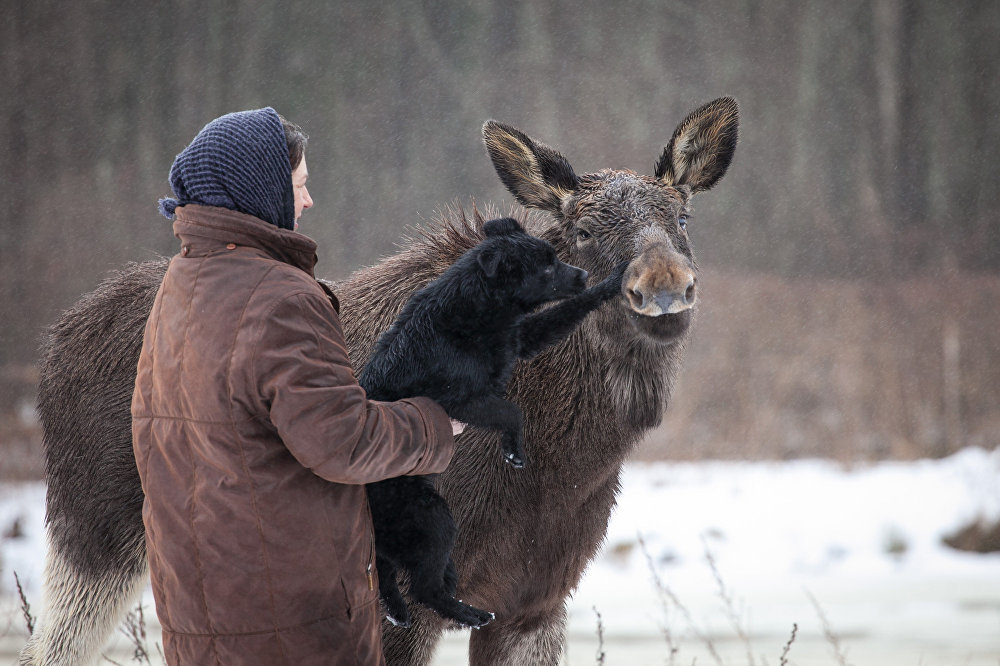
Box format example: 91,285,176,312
20,97,739,666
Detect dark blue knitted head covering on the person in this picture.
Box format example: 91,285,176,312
159,107,295,229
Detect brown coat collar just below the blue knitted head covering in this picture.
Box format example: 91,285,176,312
174,204,317,277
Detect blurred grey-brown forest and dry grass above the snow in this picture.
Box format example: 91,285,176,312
0,0,1000,478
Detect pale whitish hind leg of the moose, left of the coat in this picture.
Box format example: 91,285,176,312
18,528,148,666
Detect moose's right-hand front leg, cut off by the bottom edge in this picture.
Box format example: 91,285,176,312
469,605,566,666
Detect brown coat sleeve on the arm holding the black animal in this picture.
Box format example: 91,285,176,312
251,293,455,484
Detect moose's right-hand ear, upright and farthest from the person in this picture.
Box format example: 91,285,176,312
654,97,740,193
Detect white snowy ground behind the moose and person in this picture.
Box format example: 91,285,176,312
0,449,1000,666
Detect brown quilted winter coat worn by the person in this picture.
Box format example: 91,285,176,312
132,205,454,666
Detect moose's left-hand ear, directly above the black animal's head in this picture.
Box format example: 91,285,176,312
483,120,579,213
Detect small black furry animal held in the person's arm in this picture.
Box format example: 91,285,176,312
359,218,625,627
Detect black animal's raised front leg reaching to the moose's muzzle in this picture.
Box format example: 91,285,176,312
517,262,628,359
